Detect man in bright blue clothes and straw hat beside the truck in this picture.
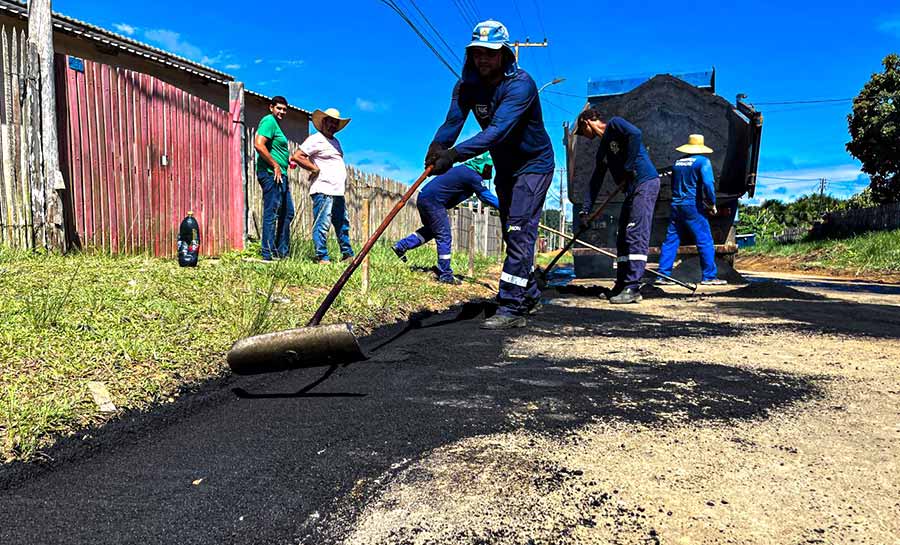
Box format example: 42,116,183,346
656,134,727,285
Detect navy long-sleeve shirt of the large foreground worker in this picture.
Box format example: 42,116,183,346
434,62,554,178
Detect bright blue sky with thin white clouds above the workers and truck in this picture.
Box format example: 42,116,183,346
53,0,900,206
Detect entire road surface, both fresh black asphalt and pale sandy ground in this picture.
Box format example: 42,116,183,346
0,278,900,545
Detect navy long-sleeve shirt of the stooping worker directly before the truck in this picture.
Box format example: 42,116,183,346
582,117,659,212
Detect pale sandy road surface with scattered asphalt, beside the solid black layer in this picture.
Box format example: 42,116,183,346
338,277,900,545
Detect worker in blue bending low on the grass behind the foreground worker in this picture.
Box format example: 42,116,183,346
394,153,500,284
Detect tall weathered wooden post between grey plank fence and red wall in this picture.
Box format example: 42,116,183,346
28,0,66,251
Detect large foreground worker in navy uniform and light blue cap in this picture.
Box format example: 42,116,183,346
425,21,554,329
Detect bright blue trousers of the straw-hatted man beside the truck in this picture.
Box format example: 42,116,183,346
659,204,718,280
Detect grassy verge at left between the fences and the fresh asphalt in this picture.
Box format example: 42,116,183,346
0,242,495,462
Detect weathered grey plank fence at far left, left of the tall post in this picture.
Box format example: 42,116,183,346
0,26,32,249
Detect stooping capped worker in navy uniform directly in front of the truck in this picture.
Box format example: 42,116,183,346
575,108,659,304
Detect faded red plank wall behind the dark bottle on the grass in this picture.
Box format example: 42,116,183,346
57,57,244,256
